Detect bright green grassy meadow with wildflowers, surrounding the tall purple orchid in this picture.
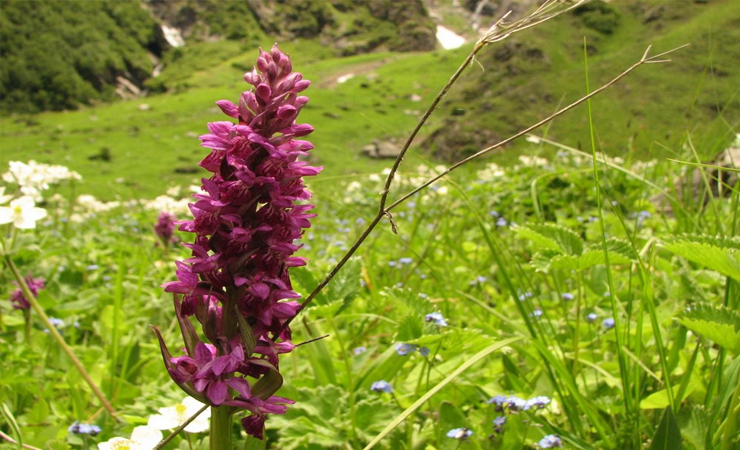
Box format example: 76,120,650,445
0,2,740,450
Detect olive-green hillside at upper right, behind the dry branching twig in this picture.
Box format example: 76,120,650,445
427,0,740,160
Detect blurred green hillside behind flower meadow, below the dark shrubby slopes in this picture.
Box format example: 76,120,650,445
0,0,740,198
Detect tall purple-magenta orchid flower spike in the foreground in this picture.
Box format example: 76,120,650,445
159,45,321,439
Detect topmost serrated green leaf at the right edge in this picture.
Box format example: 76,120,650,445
663,235,740,281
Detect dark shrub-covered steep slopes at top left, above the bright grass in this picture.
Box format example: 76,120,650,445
0,0,435,114
